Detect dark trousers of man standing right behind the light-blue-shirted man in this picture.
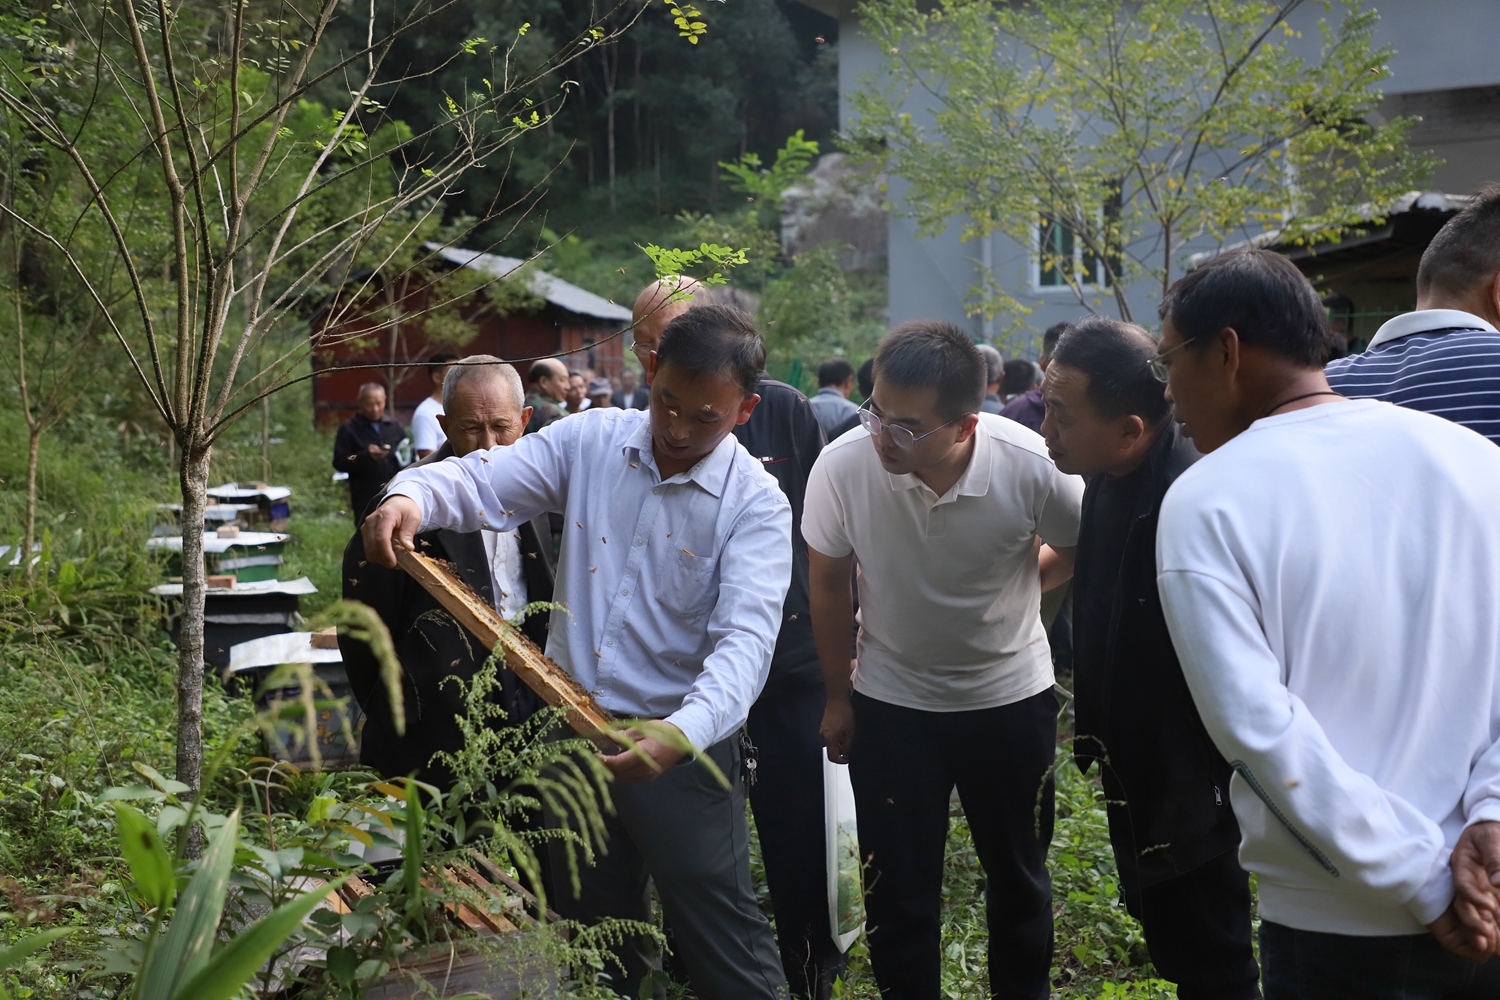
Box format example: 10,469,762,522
746,684,848,997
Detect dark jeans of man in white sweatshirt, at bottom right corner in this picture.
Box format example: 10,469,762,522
1260,921,1500,1000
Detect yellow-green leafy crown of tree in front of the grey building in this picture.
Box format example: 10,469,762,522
851,0,1433,318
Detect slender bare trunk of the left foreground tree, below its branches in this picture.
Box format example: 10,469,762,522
177,438,213,839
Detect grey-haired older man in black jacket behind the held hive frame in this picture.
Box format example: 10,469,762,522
339,355,552,789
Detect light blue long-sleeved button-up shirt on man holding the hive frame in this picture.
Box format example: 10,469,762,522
381,406,792,748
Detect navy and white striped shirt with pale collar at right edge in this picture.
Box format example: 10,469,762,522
1325,309,1500,444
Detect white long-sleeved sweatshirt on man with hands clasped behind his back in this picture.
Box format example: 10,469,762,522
1157,399,1500,936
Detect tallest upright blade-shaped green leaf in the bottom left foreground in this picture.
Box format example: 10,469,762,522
135,810,240,1000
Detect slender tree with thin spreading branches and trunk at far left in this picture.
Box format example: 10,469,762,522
0,0,651,815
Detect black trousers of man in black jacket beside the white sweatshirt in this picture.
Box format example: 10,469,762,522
1125,850,1260,1000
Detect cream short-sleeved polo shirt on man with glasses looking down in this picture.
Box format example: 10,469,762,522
803,414,1083,712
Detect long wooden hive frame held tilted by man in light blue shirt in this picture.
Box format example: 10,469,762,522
396,546,630,748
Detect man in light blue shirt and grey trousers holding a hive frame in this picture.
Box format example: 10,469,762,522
365,306,792,1000
